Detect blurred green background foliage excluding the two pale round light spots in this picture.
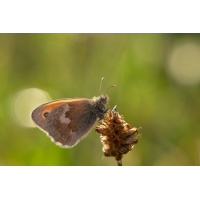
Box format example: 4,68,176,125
0,33,200,166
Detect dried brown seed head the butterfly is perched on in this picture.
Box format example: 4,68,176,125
95,106,141,166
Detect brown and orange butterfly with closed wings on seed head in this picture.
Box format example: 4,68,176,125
31,78,116,148
